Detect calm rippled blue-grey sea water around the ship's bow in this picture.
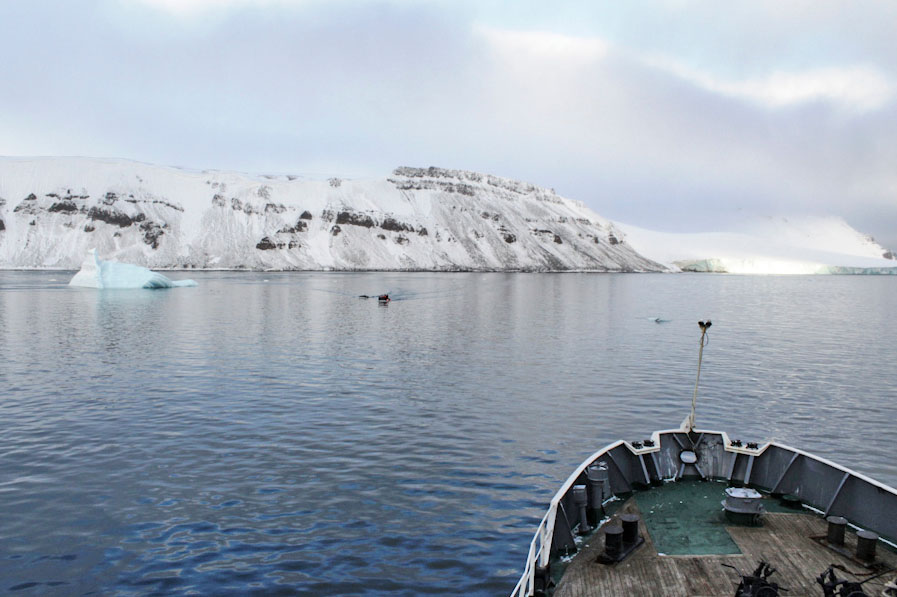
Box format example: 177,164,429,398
0,272,897,595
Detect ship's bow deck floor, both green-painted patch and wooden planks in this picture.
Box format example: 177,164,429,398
553,483,897,597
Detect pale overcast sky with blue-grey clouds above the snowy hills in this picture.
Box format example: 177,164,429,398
0,0,897,249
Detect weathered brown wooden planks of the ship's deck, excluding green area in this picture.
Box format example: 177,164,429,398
554,500,897,597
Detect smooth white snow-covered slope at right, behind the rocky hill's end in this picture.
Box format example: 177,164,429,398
617,217,897,274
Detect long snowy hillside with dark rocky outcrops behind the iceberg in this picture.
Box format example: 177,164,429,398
0,158,663,271
